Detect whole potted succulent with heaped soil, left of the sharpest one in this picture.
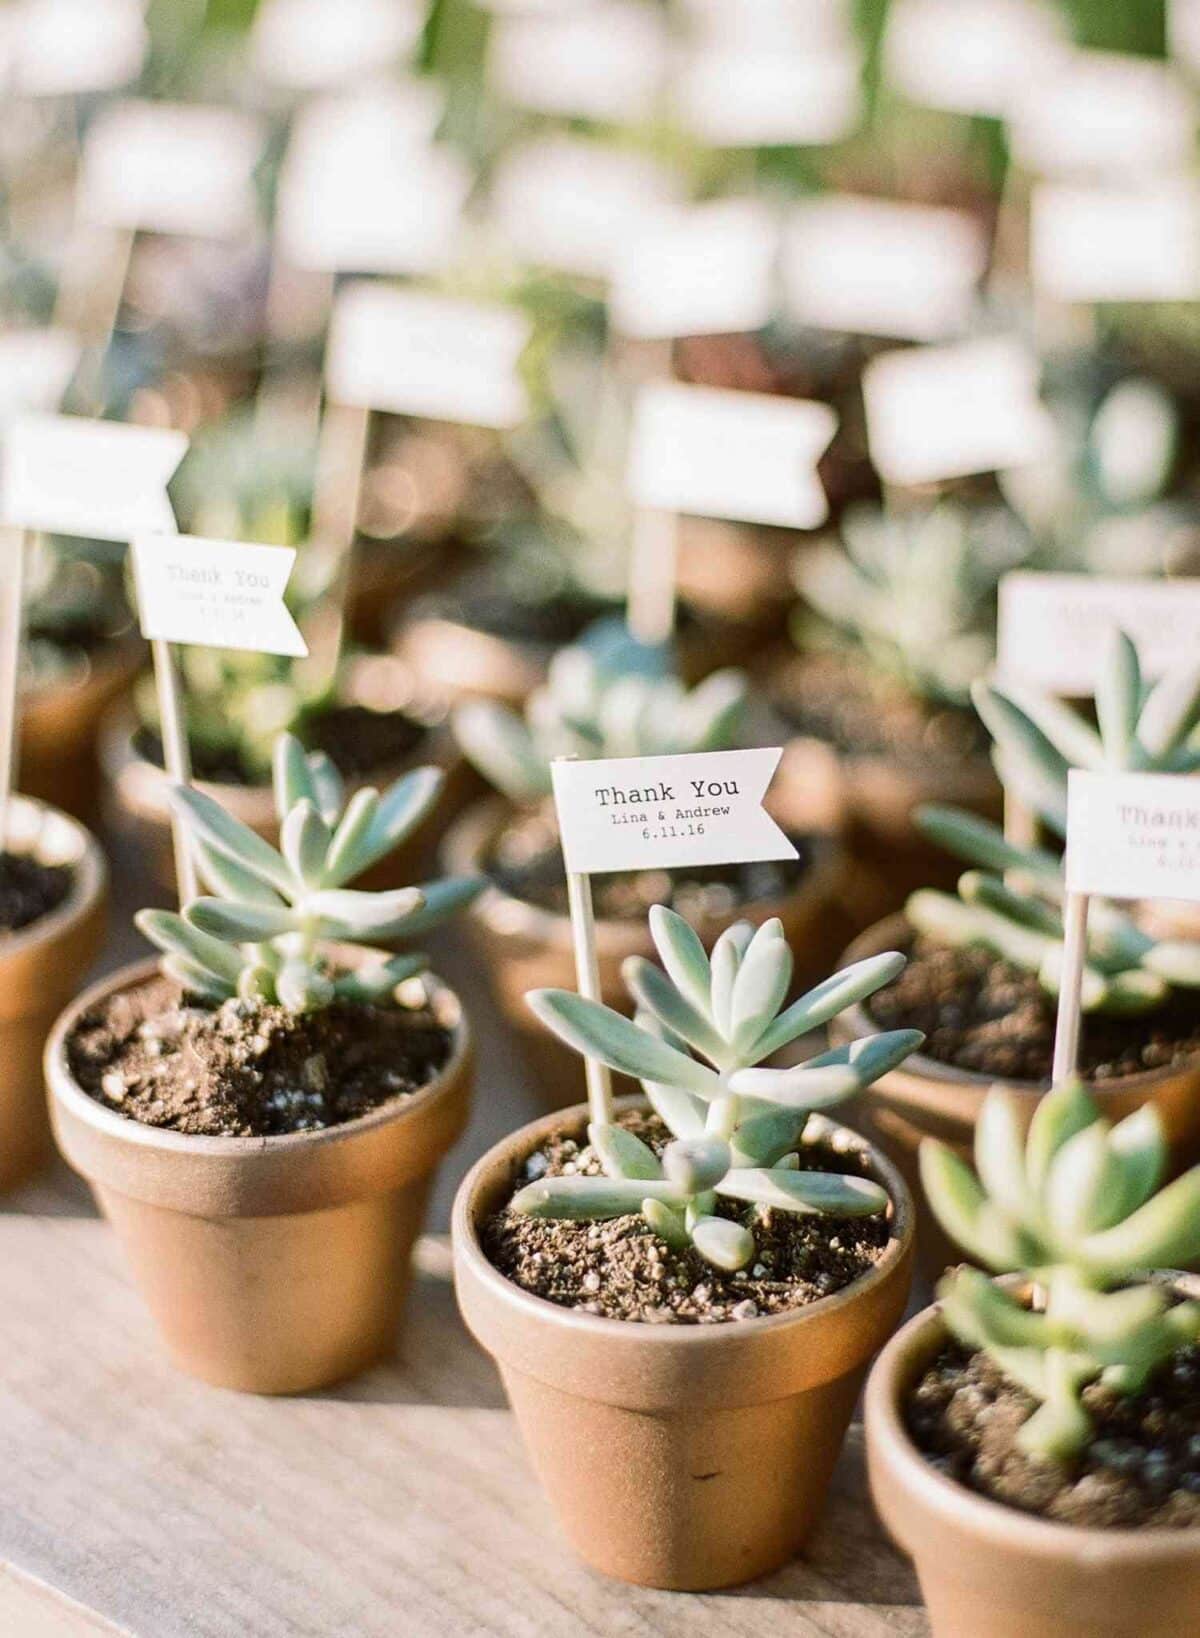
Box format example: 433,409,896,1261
46,735,480,1392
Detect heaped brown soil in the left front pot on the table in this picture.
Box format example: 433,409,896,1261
67,978,452,1137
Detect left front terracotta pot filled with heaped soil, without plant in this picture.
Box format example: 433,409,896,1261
46,962,471,1394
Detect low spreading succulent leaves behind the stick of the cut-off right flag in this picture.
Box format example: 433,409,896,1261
904,804,1200,1012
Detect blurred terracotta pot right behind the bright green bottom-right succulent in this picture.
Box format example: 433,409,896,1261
830,916,1200,1278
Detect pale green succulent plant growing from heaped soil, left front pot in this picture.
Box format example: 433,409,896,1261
134,734,483,1012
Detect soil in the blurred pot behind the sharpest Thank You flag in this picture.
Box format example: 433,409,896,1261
483,809,814,921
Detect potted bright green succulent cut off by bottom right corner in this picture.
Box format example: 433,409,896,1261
866,1083,1200,1638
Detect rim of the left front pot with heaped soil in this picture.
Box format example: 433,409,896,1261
44,957,473,1160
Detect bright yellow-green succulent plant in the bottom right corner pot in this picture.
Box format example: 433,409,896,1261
920,1081,1200,1459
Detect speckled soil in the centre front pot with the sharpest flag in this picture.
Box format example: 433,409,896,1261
483,1111,891,1325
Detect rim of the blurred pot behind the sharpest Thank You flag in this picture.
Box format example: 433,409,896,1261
442,794,843,953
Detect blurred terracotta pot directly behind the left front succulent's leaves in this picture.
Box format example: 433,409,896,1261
100,691,464,891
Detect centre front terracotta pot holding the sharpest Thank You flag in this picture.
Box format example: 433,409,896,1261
453,1107,912,1592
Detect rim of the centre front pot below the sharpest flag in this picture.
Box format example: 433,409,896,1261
450,1094,915,1355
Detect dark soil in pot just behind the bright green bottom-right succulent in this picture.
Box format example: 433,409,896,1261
868,939,1200,1084
